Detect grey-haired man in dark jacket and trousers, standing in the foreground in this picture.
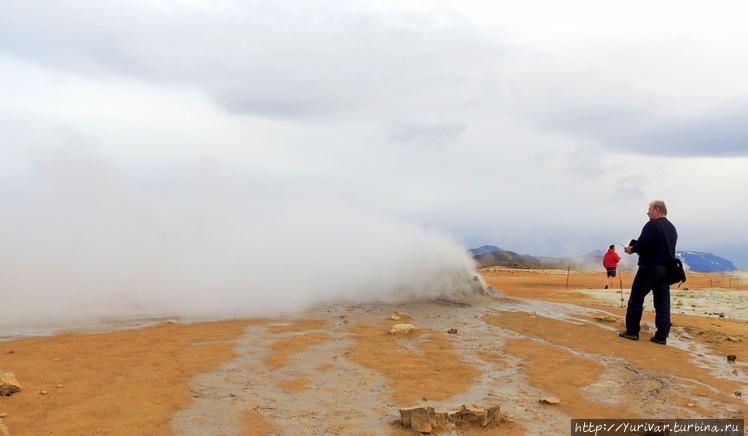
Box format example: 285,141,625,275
618,200,678,345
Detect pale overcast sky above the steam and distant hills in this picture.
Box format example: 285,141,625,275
0,0,748,268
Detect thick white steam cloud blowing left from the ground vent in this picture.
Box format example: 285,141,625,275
0,149,479,331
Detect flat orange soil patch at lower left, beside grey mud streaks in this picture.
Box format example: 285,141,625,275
0,321,260,436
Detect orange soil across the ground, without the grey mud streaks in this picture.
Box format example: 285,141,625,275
0,269,748,436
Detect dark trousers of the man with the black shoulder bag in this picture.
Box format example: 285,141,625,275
626,265,670,339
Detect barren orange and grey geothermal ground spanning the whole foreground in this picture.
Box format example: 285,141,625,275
0,269,748,436
